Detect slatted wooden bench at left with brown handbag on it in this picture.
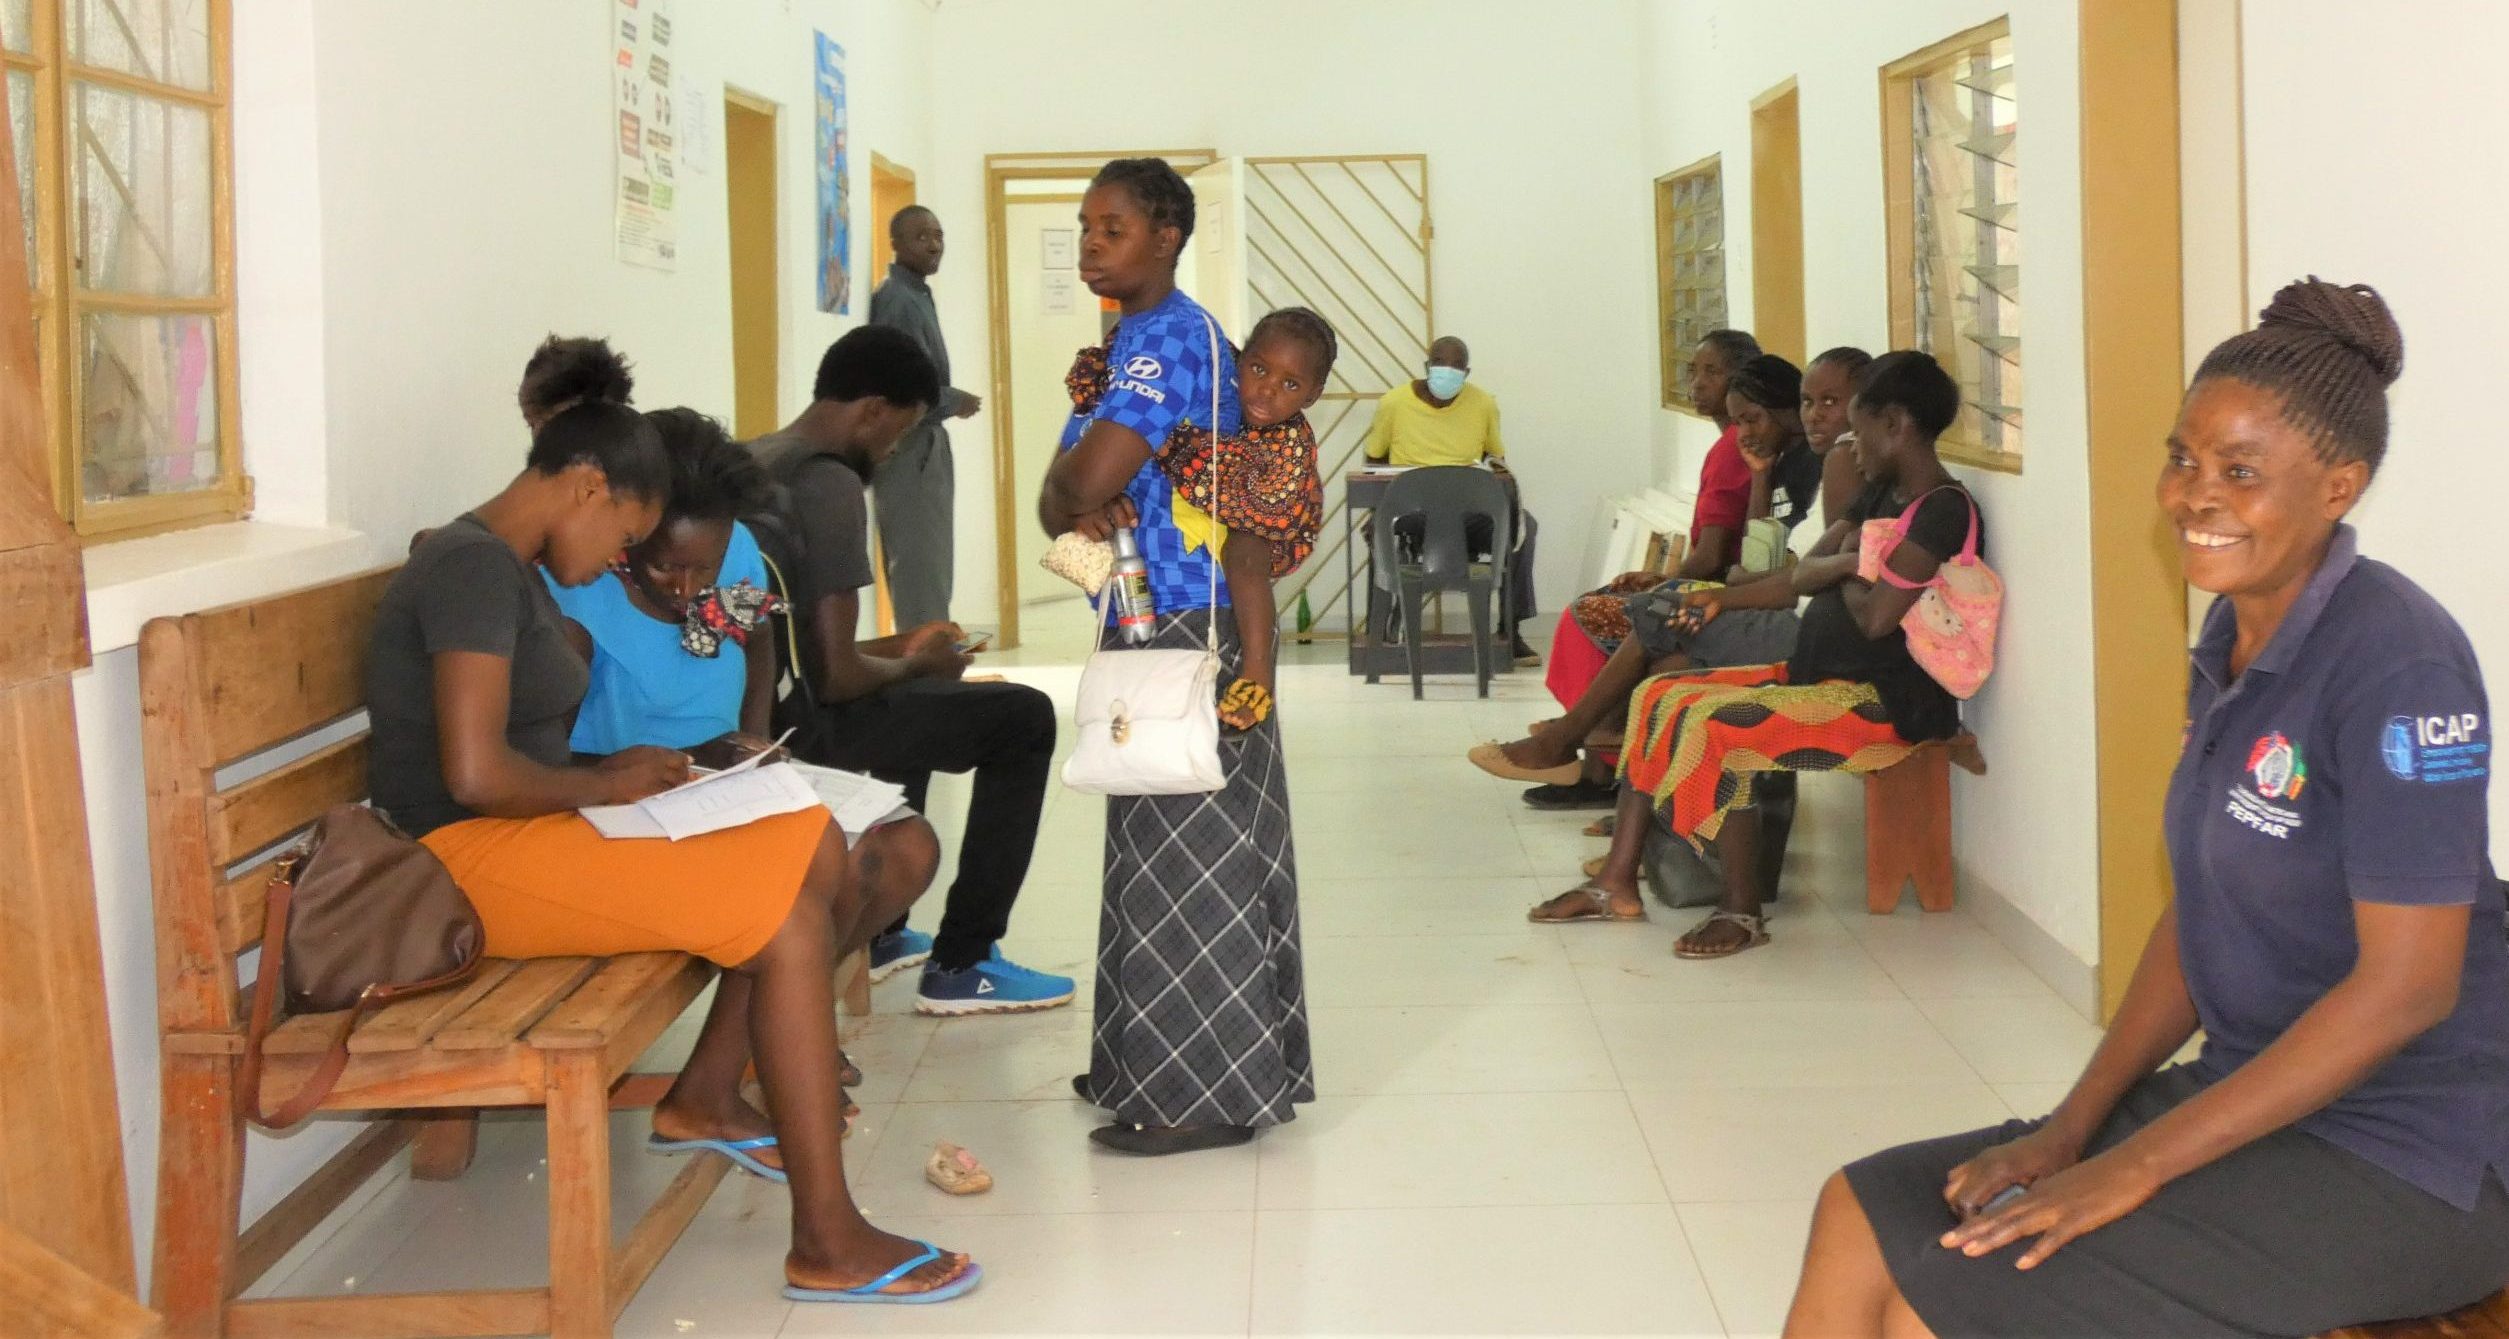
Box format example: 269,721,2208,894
141,569,730,1339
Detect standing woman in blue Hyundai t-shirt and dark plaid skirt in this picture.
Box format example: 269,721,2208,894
1036,158,1315,1153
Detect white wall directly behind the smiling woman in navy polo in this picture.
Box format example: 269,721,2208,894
2243,0,2509,860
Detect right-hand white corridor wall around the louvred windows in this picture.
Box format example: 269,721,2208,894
1646,0,2100,998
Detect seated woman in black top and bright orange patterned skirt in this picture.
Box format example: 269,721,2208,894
1533,351,1985,958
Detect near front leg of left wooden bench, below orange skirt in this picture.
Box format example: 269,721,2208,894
547,1051,615,1339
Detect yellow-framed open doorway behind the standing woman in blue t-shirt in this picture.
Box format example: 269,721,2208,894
984,150,1217,649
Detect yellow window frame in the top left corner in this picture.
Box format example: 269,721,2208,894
0,0,253,542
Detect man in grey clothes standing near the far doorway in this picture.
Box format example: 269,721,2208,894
871,206,984,627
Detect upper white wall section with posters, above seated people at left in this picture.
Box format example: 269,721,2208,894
314,0,931,551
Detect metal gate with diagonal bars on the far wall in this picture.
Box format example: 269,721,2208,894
1242,153,1435,629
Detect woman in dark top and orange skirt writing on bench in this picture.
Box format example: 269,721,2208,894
366,401,979,1301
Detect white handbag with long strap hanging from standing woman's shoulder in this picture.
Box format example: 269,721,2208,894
1064,313,1227,795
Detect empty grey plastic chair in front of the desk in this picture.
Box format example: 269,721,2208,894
1367,464,1515,700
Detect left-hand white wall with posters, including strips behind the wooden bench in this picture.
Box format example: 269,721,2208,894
73,0,933,1276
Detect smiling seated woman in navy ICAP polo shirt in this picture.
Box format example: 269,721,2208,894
1786,278,2509,1336
